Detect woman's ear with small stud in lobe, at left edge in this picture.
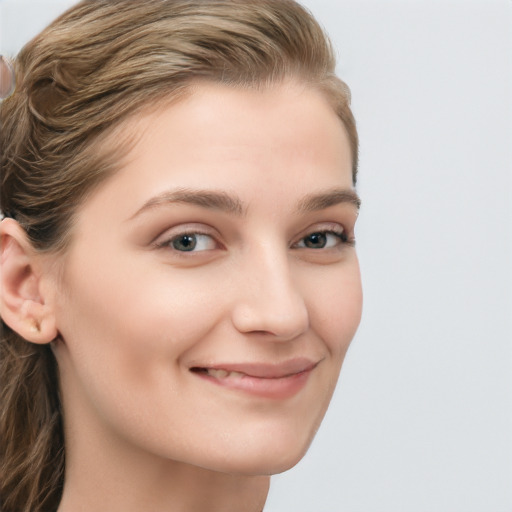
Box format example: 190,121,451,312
0,219,58,344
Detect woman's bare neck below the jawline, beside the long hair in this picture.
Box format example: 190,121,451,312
57,400,270,512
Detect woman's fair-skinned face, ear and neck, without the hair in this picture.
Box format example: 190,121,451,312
2,82,362,512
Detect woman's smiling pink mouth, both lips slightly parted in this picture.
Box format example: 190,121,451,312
190,361,318,400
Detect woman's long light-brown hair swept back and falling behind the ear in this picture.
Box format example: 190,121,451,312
0,0,358,512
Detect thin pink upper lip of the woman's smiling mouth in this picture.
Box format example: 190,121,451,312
190,358,320,379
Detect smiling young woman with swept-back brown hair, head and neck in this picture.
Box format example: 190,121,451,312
0,0,361,512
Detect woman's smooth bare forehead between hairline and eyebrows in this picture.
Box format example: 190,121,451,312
78,82,352,222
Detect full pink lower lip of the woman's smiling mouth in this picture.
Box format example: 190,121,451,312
192,369,312,400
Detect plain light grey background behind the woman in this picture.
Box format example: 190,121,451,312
0,0,512,512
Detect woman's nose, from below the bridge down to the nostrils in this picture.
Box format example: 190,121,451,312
232,247,309,341
